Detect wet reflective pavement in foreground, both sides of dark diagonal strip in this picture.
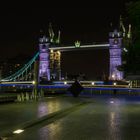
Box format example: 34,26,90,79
0,96,140,140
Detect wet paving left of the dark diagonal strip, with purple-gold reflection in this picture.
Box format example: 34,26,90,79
0,97,83,136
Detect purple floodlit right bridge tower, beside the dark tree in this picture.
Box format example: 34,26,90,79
109,30,123,80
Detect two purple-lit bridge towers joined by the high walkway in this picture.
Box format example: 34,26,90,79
39,30,123,81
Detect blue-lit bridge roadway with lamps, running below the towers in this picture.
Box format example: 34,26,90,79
0,81,140,92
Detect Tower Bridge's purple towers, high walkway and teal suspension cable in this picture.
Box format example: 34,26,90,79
1,18,131,83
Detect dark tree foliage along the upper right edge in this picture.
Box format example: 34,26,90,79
125,1,140,74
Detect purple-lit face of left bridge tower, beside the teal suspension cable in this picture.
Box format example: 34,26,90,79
39,36,50,82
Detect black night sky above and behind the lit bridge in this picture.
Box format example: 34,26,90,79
0,0,129,79
